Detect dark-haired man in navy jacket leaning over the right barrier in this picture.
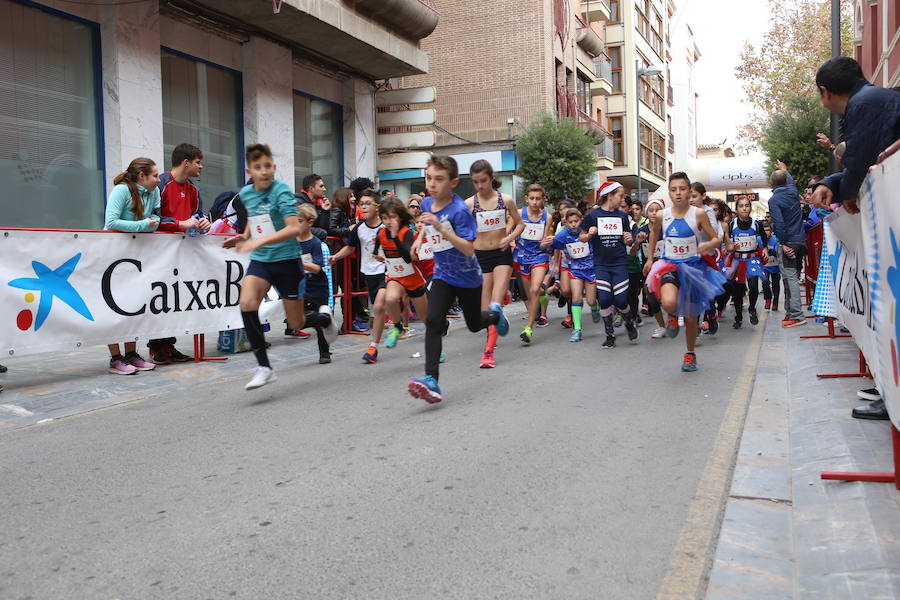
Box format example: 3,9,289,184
812,56,900,213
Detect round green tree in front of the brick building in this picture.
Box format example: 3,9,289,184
516,112,602,202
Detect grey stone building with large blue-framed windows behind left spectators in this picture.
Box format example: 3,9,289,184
0,0,438,228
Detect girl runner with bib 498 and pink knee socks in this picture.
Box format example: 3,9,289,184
466,160,525,369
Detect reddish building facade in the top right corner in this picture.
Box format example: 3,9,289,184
853,0,900,87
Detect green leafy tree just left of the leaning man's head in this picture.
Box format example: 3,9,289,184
759,94,828,189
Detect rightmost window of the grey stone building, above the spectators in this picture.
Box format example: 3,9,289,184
294,92,344,196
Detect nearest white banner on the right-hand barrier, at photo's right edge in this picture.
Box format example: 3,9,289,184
859,154,900,428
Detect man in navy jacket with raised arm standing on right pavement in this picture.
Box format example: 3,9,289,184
769,161,806,327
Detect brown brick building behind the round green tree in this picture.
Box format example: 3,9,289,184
379,0,615,202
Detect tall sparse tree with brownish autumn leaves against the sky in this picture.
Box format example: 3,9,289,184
735,0,853,150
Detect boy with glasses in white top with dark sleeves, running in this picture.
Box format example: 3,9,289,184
330,188,385,364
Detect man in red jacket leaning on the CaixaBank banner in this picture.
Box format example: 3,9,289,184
153,144,210,365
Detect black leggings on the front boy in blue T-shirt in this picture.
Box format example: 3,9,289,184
425,279,499,379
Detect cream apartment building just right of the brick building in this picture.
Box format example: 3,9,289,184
606,0,676,200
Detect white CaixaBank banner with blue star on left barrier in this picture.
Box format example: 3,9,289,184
0,230,249,357
